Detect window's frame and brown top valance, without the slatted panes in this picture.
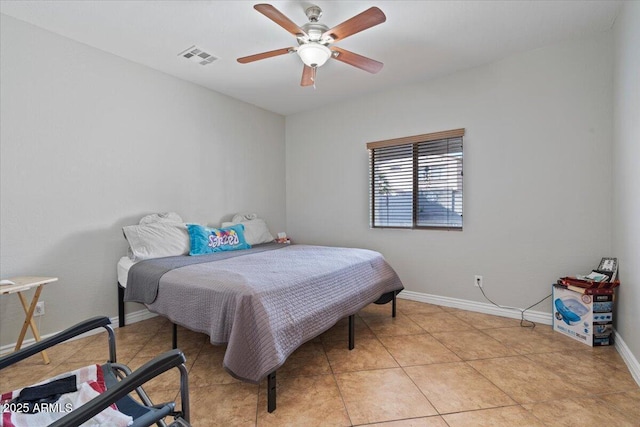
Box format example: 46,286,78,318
366,128,465,231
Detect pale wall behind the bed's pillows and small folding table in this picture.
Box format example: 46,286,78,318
0,15,285,344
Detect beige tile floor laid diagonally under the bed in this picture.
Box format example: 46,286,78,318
0,299,640,427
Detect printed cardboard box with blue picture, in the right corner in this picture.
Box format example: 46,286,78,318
552,285,615,347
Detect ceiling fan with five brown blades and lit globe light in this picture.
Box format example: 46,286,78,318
238,4,387,86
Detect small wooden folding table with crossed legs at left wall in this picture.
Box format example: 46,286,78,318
0,276,58,364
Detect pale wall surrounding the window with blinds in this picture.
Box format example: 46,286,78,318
286,34,613,311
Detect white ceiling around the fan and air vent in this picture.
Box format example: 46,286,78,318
0,0,621,115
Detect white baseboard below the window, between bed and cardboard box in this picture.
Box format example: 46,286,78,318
398,290,552,325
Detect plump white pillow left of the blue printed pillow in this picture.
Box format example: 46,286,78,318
122,222,190,261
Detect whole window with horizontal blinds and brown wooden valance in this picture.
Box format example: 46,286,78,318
367,129,464,230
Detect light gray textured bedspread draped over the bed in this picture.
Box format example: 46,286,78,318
127,245,403,383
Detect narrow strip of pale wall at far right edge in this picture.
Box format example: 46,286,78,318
612,2,640,360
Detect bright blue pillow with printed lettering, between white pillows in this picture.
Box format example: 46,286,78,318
187,224,251,255
